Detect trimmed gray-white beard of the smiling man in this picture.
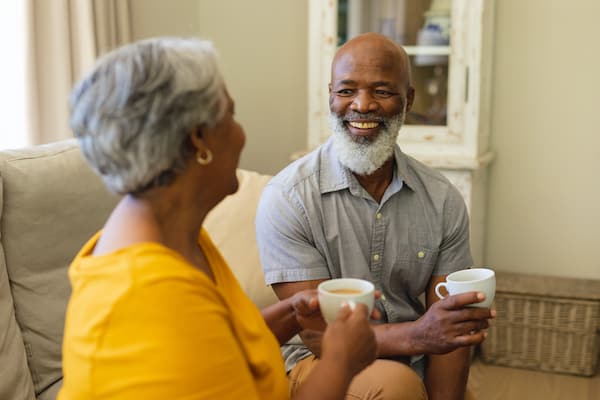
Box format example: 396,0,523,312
329,112,404,175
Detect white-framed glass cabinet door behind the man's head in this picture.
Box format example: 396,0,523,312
308,0,480,154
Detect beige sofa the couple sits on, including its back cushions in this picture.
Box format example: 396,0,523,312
0,140,276,400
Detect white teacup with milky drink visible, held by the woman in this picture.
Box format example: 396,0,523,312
317,278,375,323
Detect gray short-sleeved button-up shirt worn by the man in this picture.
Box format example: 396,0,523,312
256,139,472,364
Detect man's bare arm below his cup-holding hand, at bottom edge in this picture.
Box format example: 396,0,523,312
425,347,471,400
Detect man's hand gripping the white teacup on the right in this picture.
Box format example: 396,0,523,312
414,292,496,354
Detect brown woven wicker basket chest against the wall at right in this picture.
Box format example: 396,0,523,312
481,273,600,376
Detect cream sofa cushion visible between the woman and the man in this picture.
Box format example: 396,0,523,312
204,169,277,308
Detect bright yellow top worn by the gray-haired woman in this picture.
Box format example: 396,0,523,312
58,230,289,400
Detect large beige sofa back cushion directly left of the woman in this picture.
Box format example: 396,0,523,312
0,140,118,399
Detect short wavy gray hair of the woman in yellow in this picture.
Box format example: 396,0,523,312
70,38,226,194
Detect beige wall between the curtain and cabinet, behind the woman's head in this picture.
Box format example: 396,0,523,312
132,0,308,174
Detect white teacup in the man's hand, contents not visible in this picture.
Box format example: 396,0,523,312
435,268,496,308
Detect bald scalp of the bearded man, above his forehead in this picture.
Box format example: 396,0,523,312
331,32,410,87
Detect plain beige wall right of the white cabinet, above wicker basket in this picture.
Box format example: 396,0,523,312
485,0,600,279
